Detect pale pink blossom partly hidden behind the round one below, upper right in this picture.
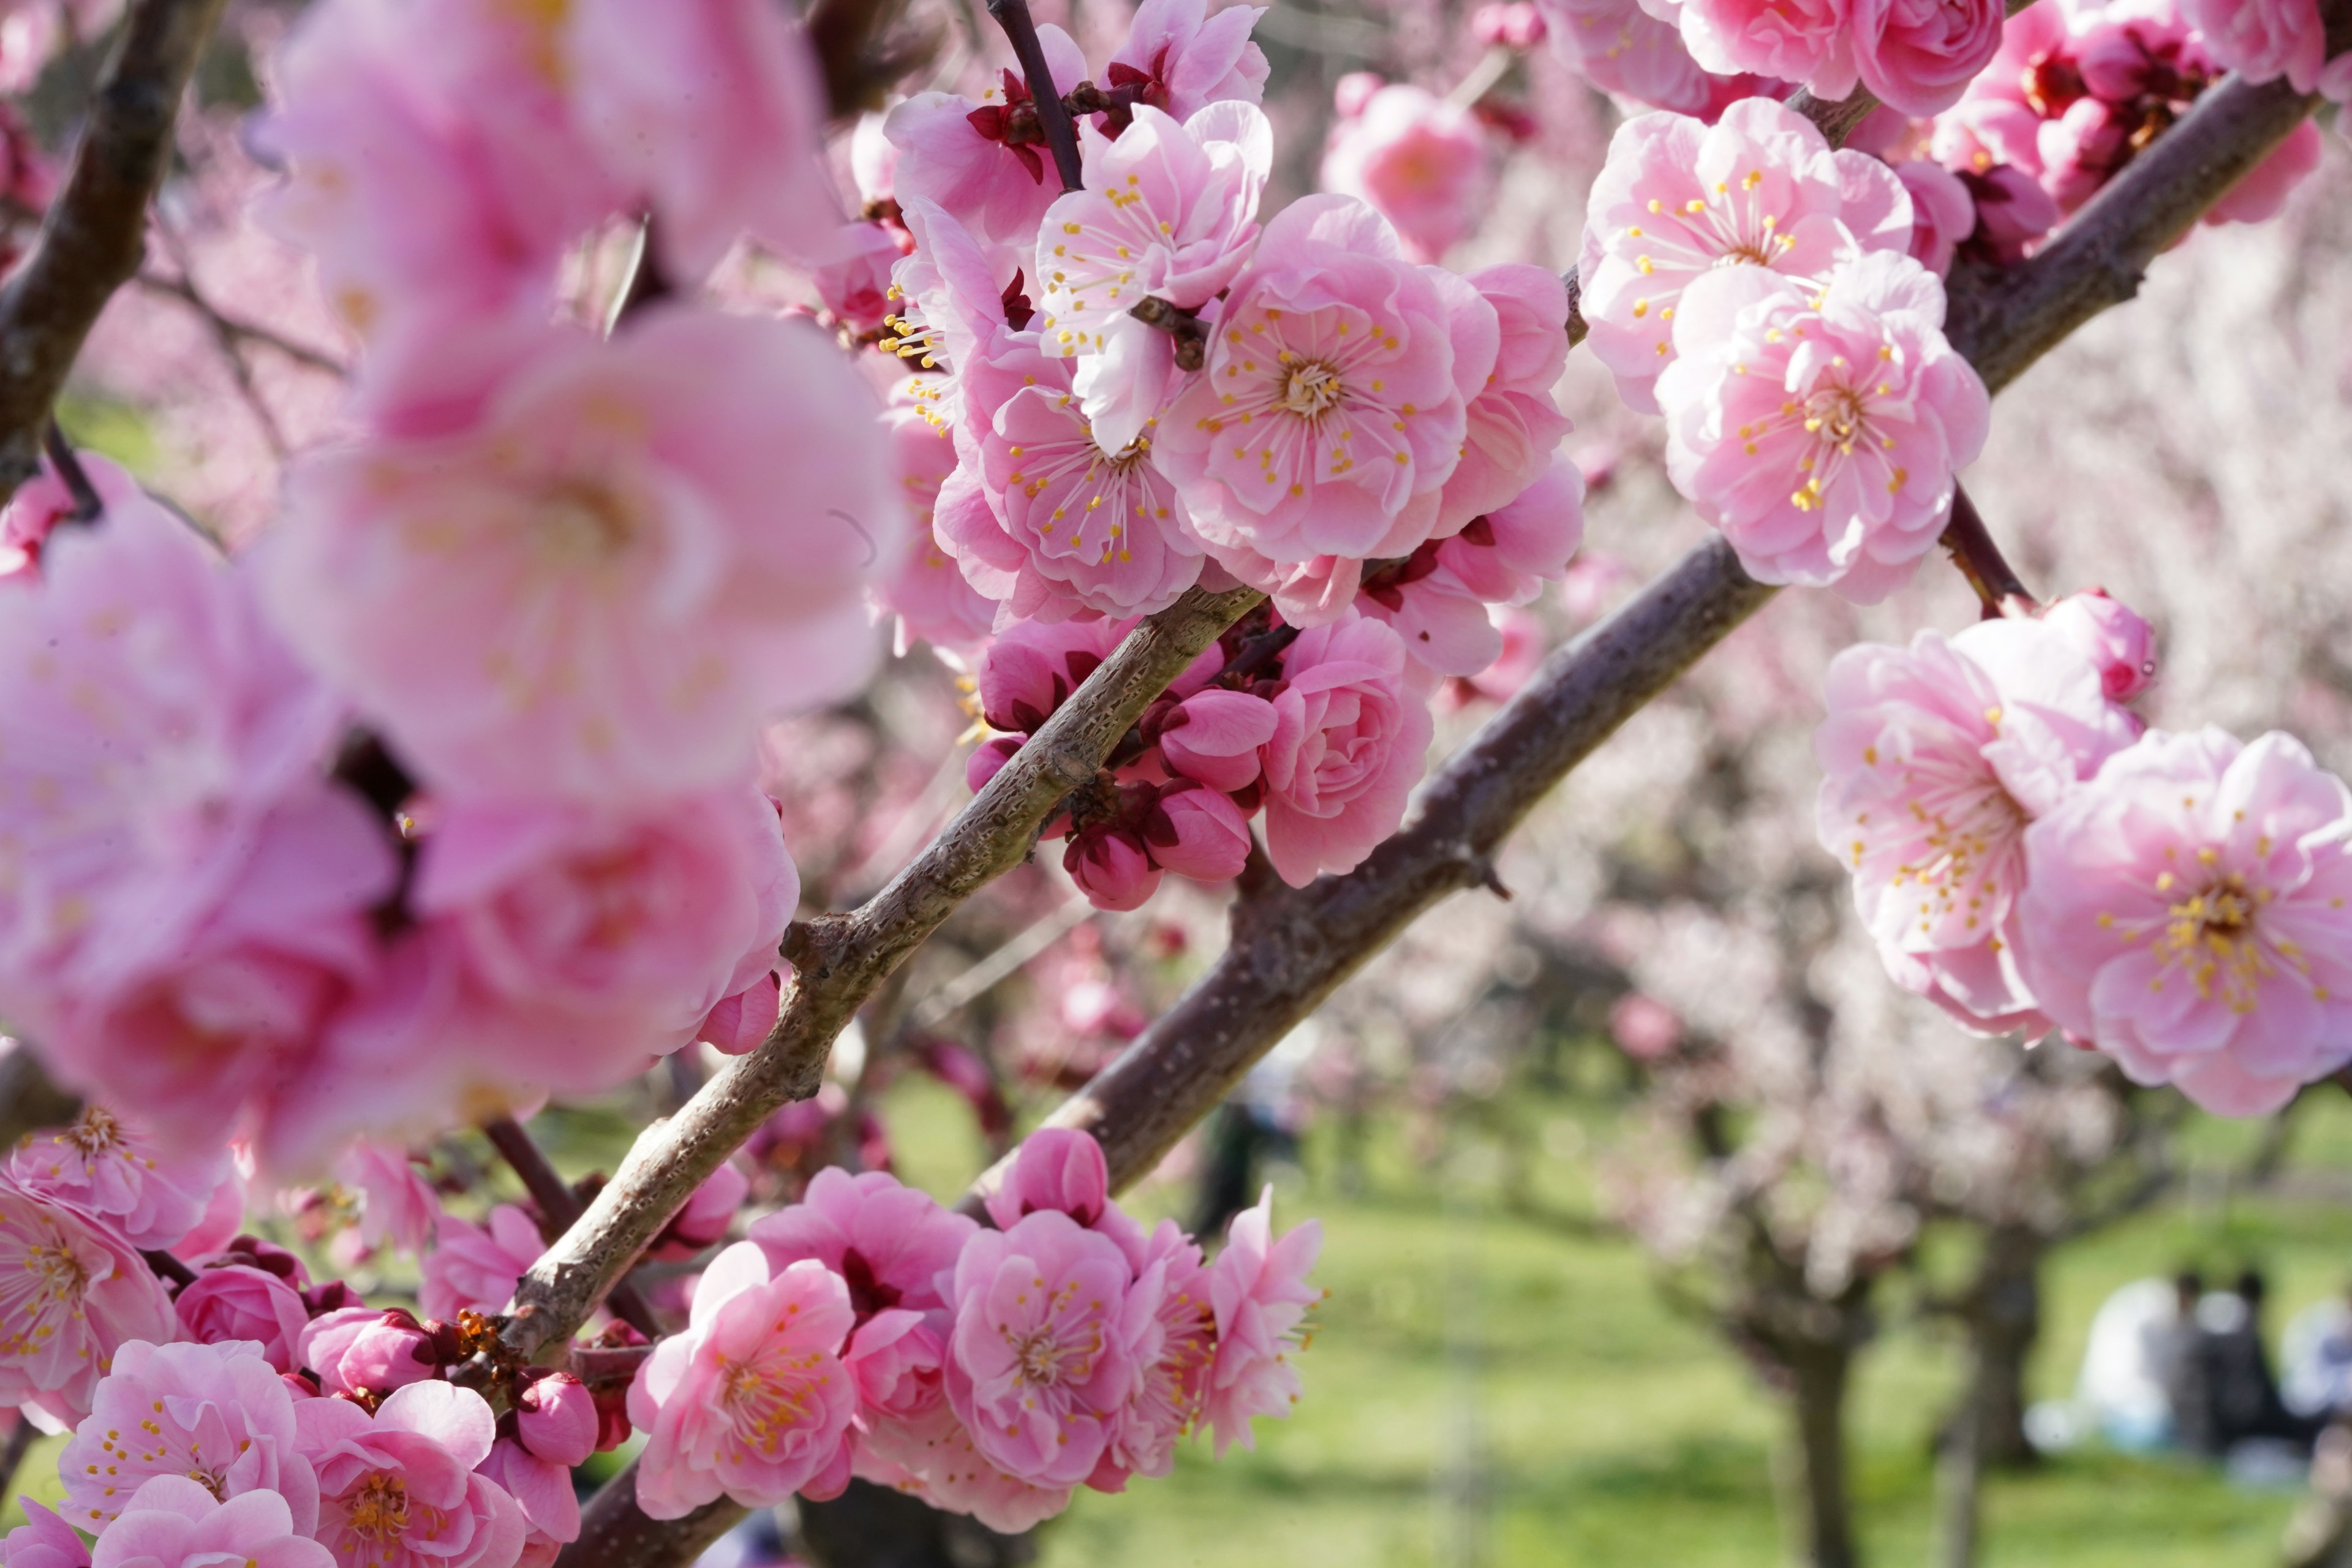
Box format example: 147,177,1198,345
1578,99,1912,414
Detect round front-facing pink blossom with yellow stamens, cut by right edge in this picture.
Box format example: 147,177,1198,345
2021,729,2352,1117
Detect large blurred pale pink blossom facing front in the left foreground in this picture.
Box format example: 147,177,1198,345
268,306,903,799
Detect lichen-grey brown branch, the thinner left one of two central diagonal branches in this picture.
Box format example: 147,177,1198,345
503,588,1261,1359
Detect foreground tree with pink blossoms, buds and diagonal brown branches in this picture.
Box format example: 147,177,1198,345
0,0,2352,1568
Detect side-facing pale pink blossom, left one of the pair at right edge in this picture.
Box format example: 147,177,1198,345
1814,620,2138,1032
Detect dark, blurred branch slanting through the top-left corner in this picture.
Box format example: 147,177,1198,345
0,0,224,499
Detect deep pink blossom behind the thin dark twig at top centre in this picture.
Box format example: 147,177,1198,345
882,23,1087,247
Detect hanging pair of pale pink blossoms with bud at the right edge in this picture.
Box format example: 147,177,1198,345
1814,592,2352,1117
